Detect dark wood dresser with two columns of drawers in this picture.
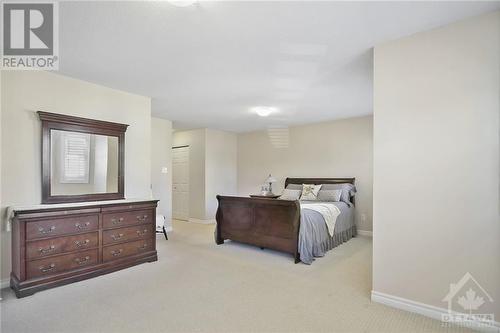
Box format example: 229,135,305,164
10,200,158,297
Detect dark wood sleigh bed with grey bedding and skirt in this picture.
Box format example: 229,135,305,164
215,178,356,264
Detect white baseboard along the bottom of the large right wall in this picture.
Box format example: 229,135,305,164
371,290,500,333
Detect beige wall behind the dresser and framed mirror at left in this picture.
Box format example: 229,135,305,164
1,71,151,279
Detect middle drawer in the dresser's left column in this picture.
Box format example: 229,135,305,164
26,232,99,260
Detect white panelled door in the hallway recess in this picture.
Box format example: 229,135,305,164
172,147,189,221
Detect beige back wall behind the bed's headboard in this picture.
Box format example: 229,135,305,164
238,116,373,230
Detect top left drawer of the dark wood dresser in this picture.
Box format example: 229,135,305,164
26,215,99,240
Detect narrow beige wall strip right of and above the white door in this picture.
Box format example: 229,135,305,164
173,129,205,220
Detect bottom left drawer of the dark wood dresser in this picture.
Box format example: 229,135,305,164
26,249,98,279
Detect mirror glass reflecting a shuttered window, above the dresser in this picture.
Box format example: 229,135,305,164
50,129,119,195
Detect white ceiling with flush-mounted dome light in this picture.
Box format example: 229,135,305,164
59,1,500,132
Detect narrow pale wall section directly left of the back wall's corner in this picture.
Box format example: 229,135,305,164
205,129,238,219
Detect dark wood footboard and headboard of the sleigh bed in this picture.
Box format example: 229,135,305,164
215,178,355,263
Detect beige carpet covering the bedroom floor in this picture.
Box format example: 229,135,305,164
0,221,470,333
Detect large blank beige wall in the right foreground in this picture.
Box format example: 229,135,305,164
373,12,500,320
